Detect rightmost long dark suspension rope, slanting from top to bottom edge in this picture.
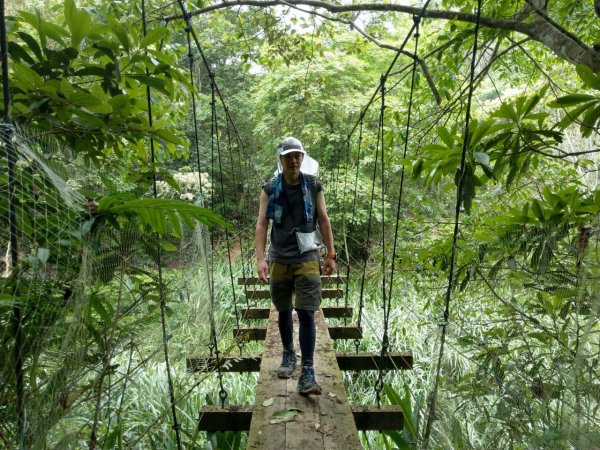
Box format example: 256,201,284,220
423,0,481,448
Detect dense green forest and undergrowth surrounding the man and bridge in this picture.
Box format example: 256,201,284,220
0,0,600,448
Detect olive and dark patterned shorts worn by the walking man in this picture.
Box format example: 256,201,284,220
269,259,321,311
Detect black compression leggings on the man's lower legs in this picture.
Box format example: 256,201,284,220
279,309,317,366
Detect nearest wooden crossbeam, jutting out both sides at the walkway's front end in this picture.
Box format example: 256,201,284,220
198,405,404,432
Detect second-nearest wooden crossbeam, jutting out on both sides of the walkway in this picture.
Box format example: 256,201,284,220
186,352,413,372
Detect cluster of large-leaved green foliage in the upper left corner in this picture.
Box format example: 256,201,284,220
9,0,187,164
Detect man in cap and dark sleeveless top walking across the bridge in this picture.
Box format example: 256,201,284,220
256,137,336,395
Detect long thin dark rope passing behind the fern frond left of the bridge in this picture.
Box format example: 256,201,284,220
142,0,182,450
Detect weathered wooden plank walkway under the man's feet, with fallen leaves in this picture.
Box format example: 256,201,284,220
247,308,361,450
